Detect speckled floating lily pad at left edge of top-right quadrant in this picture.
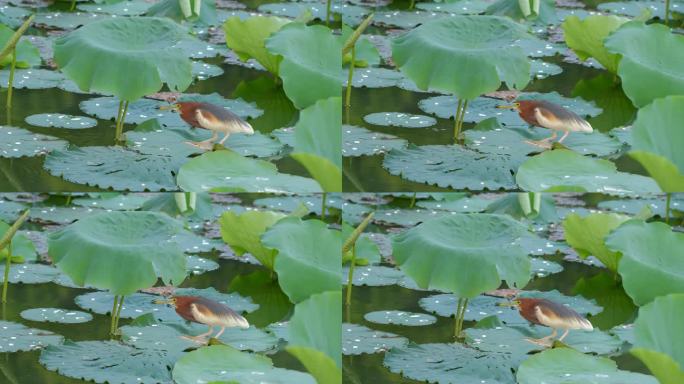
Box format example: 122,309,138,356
342,125,407,157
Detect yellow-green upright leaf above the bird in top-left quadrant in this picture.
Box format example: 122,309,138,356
223,16,291,75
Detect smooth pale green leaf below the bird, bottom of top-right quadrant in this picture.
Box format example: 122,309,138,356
516,149,660,195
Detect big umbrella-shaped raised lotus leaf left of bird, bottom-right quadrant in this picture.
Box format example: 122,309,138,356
392,214,530,298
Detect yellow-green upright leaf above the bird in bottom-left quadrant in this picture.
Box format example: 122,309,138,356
219,211,285,270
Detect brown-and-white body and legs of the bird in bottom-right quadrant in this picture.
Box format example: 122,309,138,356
515,297,594,344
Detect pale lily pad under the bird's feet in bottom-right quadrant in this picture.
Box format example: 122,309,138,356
465,326,622,361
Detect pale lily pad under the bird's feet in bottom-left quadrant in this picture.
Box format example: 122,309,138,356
121,323,278,357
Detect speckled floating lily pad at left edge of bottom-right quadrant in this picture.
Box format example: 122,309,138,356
342,323,408,355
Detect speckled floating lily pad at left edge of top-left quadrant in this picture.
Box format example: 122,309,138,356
0,126,67,158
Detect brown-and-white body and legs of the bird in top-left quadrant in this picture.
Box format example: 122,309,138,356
176,101,254,149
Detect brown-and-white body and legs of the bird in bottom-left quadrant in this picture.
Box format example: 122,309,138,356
169,296,249,340
